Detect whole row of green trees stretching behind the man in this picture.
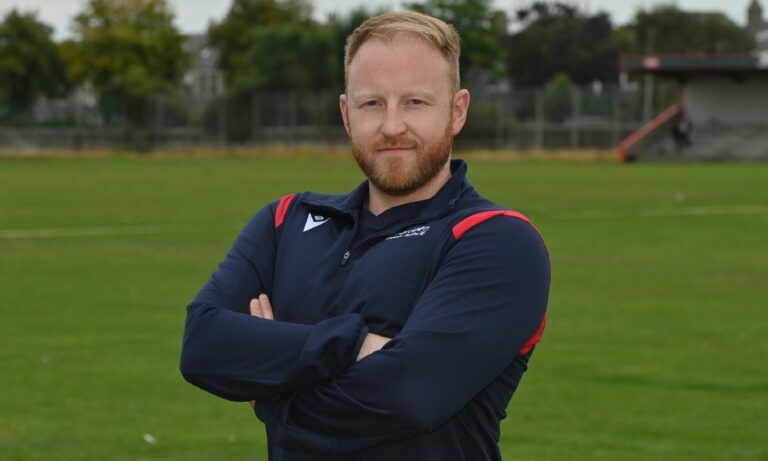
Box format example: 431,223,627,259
0,0,755,123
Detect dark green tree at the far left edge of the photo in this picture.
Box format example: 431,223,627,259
0,9,66,120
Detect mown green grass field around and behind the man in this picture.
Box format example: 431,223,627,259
0,156,768,461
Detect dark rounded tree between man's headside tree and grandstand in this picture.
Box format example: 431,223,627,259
504,2,619,86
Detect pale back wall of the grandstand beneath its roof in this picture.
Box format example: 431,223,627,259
685,74,768,126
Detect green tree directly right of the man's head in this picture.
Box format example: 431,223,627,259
406,0,506,81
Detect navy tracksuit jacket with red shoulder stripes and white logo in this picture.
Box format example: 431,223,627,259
181,161,550,461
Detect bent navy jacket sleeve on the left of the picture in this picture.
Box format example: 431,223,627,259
181,199,368,401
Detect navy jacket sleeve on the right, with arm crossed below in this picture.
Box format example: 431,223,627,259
258,217,550,456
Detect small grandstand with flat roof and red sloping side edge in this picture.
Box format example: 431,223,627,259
619,51,768,160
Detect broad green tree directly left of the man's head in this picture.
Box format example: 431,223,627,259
209,0,342,140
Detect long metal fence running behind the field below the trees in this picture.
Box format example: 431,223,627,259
0,79,677,152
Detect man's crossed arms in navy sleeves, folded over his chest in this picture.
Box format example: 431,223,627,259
182,204,549,455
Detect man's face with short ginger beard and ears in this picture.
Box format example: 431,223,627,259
339,37,469,196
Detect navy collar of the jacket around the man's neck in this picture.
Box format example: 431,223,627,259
302,159,473,219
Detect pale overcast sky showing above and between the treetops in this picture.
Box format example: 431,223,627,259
0,0,756,39
